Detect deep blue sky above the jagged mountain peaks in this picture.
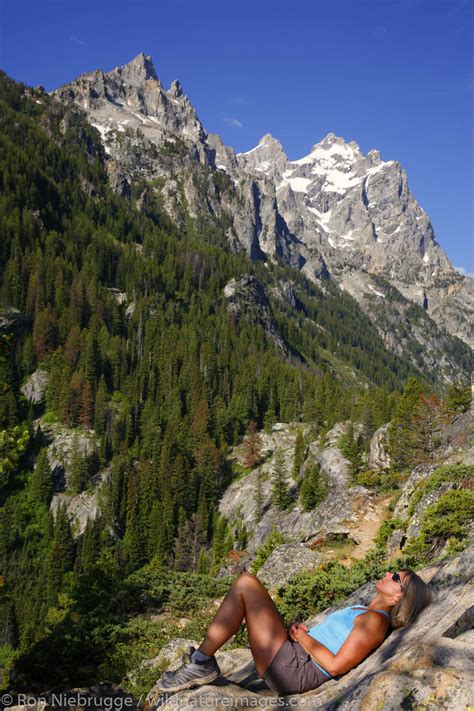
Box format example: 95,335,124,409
0,0,474,274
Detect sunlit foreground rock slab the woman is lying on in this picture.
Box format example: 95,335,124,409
145,546,474,711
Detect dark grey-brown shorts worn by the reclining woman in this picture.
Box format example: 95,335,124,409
263,639,330,696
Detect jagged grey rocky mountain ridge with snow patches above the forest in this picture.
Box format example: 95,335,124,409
53,53,474,354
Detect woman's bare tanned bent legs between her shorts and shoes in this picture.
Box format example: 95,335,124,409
199,573,288,676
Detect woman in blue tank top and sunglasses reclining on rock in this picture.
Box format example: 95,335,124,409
157,570,431,695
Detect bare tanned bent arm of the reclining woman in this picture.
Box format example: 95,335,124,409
297,613,387,676
